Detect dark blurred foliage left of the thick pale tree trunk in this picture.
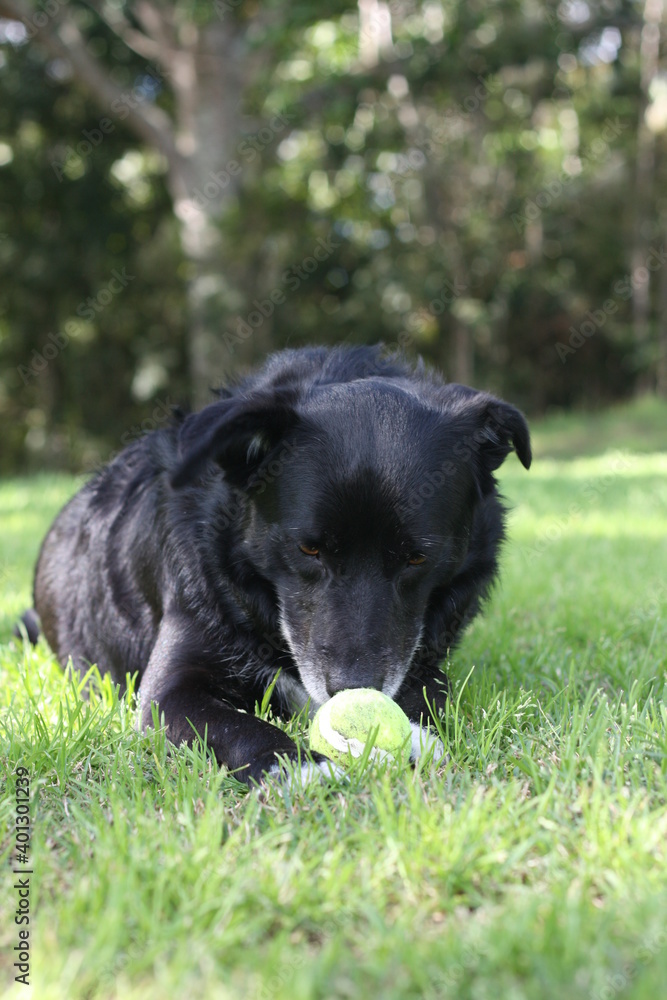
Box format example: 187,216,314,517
0,13,188,473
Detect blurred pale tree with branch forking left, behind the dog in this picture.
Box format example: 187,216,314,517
0,0,284,401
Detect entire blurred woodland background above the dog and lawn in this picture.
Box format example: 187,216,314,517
0,0,667,473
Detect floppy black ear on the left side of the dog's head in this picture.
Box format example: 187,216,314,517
171,390,297,489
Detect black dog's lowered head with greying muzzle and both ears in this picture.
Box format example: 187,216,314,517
172,377,531,704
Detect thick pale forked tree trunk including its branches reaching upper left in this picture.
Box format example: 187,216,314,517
0,0,280,404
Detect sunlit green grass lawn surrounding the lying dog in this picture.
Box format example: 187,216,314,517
0,401,667,1000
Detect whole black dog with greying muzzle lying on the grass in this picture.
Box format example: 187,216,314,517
26,347,531,781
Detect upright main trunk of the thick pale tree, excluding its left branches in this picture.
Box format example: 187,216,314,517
170,22,268,405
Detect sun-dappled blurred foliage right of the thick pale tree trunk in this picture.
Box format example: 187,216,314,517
226,3,664,412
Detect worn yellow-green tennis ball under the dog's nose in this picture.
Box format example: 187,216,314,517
310,688,412,764
